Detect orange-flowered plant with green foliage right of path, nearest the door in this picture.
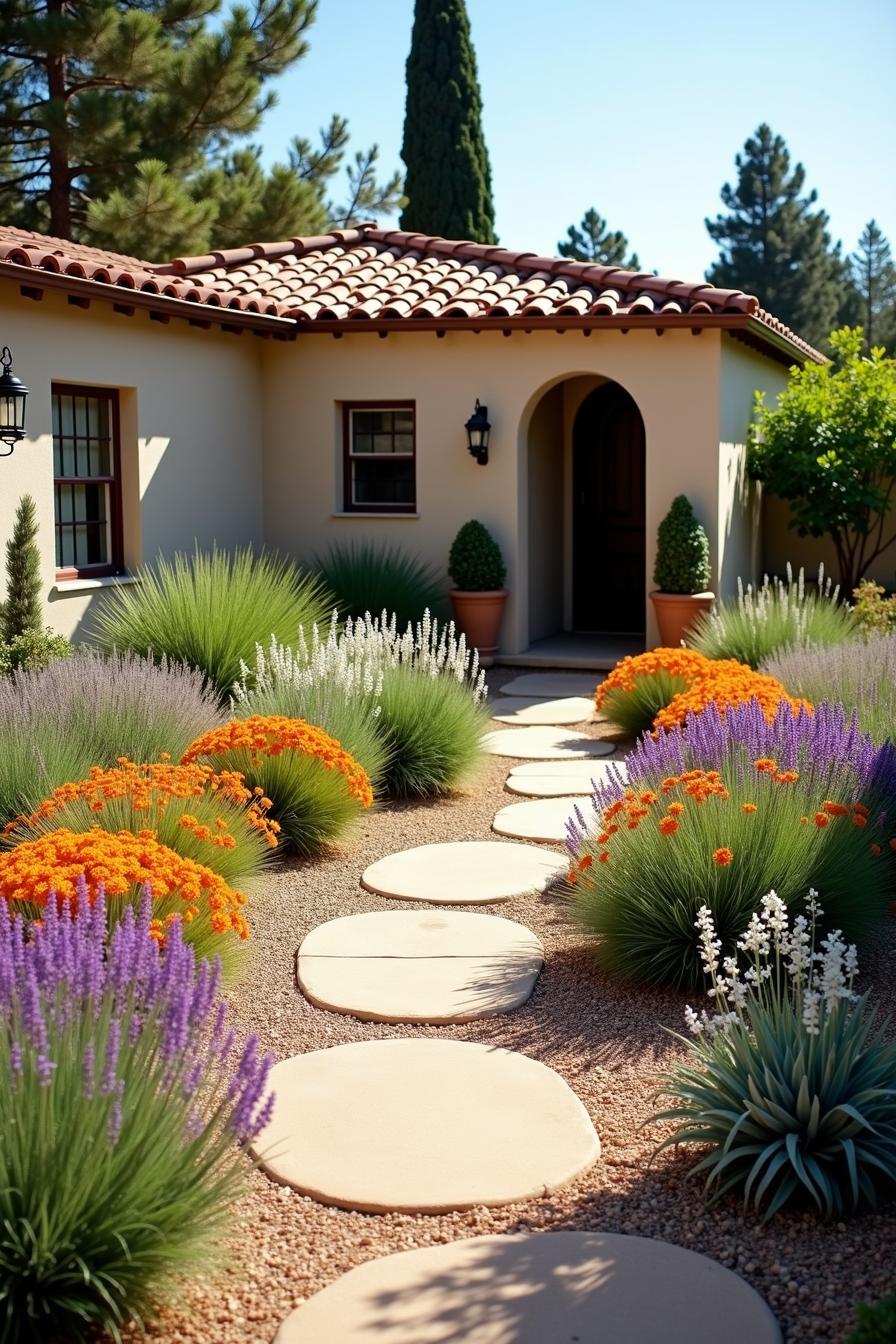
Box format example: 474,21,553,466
595,649,809,737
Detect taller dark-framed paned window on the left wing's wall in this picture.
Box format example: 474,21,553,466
52,383,122,578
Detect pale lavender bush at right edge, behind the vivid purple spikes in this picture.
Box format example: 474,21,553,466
763,633,896,743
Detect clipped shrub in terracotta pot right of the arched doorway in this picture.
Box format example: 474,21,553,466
650,495,715,648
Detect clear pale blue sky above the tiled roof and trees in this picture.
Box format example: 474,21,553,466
255,0,896,278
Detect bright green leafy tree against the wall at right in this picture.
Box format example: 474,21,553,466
748,327,896,593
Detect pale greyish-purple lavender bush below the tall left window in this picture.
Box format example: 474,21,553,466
0,649,223,825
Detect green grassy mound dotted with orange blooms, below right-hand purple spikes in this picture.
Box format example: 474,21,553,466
568,752,888,988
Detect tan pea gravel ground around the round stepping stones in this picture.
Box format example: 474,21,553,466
134,672,896,1344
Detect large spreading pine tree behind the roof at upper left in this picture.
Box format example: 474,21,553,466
0,0,400,259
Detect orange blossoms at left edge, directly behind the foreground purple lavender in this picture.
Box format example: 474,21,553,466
0,827,249,941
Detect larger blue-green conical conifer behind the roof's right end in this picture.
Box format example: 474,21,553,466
705,125,846,345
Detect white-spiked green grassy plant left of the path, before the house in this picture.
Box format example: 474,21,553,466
232,612,488,797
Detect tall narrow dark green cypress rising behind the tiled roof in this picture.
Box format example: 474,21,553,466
400,0,497,243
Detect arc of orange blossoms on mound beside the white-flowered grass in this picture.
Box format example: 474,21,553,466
181,714,373,808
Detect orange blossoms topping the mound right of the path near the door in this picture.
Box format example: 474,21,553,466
595,649,811,731
